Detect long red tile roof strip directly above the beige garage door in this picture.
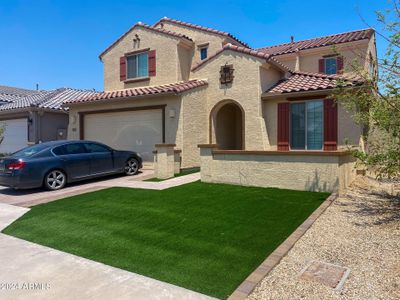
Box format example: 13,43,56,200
65,79,208,104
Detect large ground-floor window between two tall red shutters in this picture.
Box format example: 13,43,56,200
290,100,324,150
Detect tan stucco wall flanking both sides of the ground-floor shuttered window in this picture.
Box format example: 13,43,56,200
263,97,362,150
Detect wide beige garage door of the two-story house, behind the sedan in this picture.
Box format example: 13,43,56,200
84,109,163,161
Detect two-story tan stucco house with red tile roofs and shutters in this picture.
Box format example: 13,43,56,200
67,18,376,191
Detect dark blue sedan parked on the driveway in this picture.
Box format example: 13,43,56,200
0,141,142,190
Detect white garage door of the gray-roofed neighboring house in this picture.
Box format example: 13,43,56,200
0,119,28,153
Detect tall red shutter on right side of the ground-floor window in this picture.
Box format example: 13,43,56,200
324,99,338,151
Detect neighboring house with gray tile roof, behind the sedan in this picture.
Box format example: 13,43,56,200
0,86,93,153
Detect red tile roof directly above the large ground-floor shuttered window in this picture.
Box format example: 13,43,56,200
266,72,364,95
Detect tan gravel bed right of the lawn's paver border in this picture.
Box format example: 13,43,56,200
249,177,400,299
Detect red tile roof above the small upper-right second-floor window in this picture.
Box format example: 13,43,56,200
257,28,375,55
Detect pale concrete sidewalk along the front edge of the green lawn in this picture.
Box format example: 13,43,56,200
0,203,212,300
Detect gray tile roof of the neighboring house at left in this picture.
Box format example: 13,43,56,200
0,88,95,112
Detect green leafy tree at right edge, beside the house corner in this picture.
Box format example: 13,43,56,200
335,0,400,177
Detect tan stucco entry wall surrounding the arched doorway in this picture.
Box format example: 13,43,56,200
192,51,279,150
